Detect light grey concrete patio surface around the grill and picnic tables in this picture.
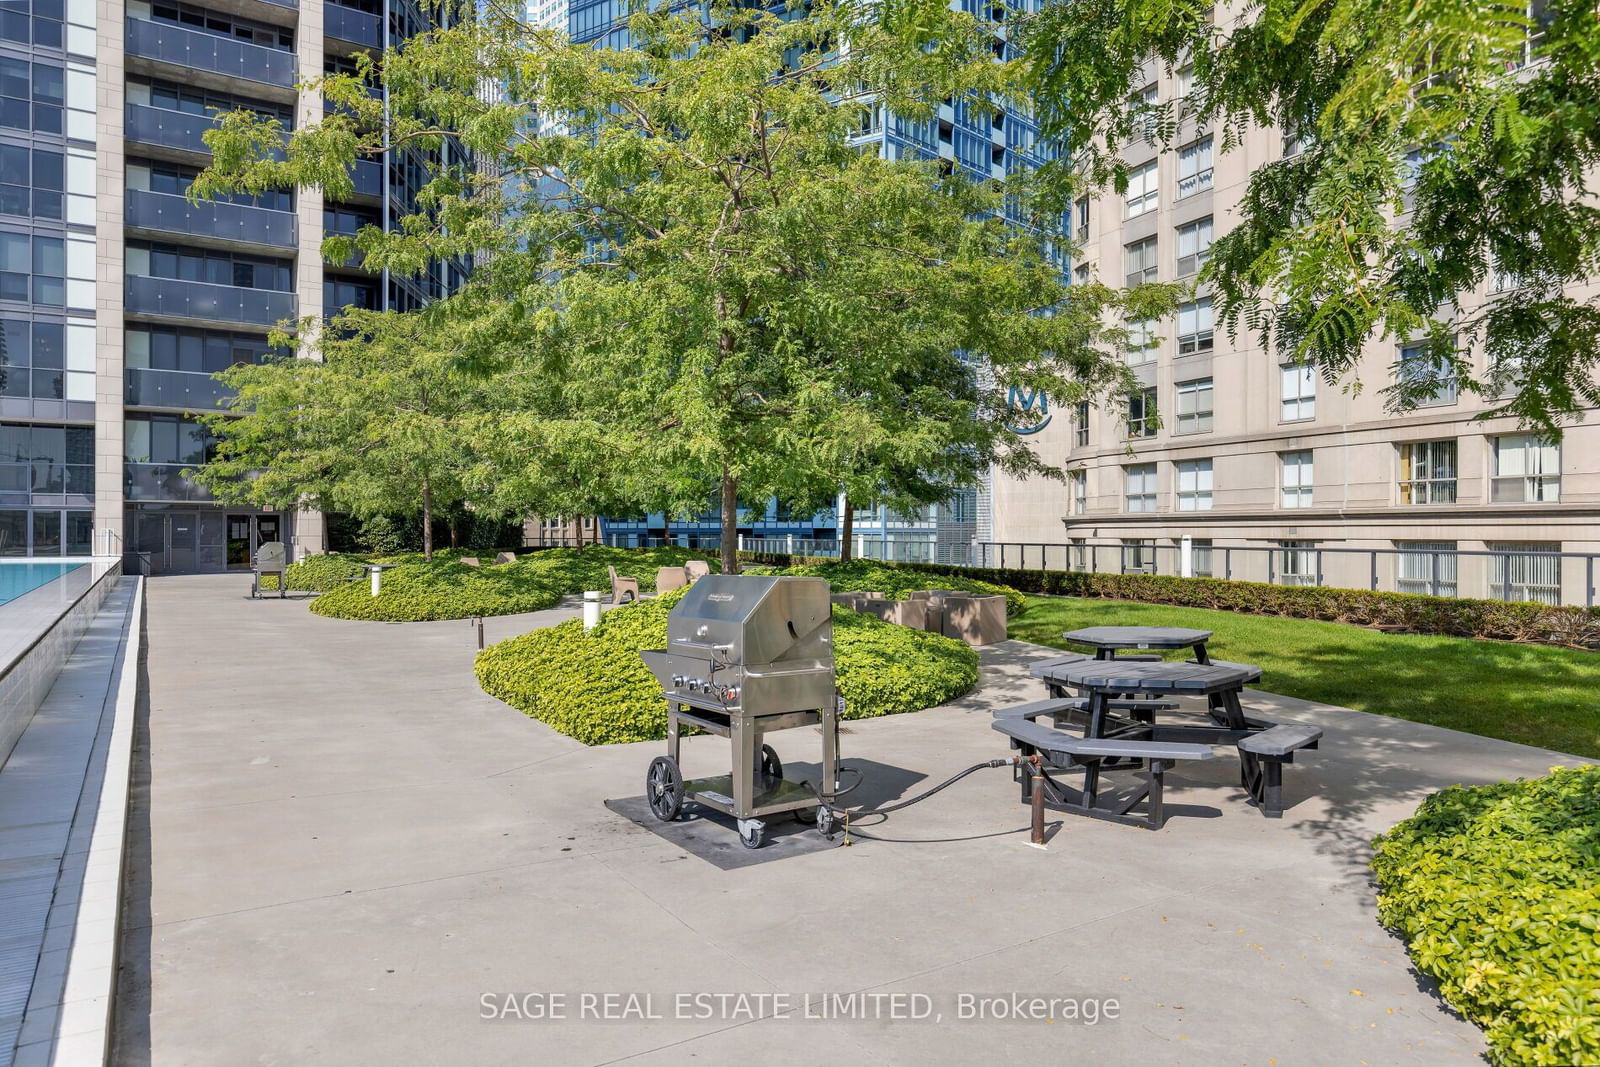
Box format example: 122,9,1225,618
118,576,1573,1065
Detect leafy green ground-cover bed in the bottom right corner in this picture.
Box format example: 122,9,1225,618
1373,766,1600,1064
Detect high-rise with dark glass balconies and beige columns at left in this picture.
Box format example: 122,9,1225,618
0,0,464,573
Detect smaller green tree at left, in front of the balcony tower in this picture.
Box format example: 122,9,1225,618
194,309,496,558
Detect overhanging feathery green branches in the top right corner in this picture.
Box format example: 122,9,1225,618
1021,0,1600,432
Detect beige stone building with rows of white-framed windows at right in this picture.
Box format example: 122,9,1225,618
989,58,1600,603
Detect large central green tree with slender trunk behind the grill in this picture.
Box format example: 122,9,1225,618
195,0,1170,571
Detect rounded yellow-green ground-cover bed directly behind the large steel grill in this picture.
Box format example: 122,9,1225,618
475,592,978,744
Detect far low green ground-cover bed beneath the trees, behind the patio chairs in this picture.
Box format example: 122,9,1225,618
305,545,715,622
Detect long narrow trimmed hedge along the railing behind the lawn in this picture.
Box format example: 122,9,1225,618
739,563,1600,648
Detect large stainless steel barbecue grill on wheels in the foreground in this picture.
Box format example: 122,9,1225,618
640,574,838,848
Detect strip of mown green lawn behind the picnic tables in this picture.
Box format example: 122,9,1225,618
1010,597,1600,758
